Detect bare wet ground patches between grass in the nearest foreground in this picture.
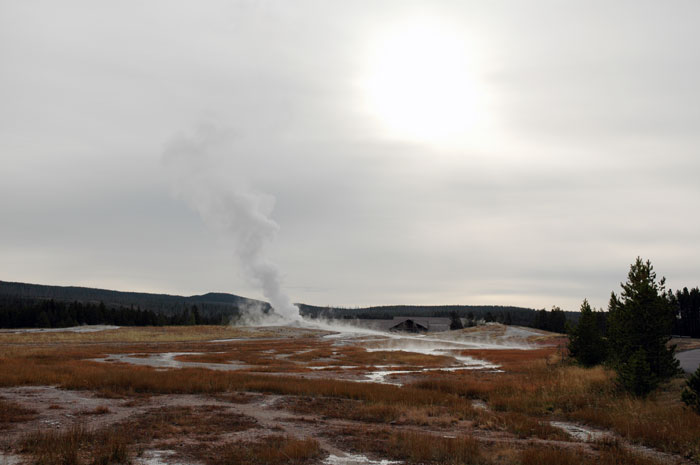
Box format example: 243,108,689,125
0,386,686,465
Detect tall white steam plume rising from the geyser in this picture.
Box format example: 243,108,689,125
163,126,300,324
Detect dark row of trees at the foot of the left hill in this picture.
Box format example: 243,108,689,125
0,298,226,328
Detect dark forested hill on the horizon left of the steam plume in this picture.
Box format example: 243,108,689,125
0,281,269,316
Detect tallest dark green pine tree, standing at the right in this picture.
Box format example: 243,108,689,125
608,257,678,395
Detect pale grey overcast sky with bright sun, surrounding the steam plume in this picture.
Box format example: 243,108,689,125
0,0,700,310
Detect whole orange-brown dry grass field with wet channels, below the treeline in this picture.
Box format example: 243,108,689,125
0,327,700,465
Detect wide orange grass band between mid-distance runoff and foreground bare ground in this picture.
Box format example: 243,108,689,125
0,330,700,454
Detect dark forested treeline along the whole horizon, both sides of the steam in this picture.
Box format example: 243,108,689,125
0,281,700,337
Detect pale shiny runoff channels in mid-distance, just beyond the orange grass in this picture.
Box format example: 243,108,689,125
86,327,520,386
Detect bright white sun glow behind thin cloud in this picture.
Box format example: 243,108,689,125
363,20,480,144
